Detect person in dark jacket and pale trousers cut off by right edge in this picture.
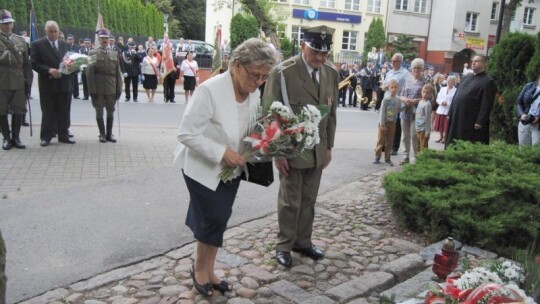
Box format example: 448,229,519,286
517,75,540,146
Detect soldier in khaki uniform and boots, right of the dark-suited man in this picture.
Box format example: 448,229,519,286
86,29,122,143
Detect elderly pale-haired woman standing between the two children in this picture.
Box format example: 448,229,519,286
399,58,424,165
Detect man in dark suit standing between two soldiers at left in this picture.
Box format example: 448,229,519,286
30,21,75,147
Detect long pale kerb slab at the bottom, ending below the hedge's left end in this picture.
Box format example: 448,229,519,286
324,272,394,303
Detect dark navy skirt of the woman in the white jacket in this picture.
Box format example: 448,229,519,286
183,174,240,247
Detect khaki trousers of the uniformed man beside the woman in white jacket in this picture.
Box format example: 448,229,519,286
276,166,323,252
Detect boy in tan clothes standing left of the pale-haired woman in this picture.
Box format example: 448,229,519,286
373,79,401,166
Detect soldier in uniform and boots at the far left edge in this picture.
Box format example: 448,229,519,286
0,9,34,150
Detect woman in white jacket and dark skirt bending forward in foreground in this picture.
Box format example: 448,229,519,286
175,38,277,296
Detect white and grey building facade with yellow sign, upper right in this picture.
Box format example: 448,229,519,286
387,0,540,73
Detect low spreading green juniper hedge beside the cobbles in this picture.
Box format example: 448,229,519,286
383,142,540,255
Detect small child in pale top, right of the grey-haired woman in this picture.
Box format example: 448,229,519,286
416,84,433,152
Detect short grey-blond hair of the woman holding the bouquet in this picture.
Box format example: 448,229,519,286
229,38,278,67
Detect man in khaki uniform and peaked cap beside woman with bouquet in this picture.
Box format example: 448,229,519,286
263,26,339,267
